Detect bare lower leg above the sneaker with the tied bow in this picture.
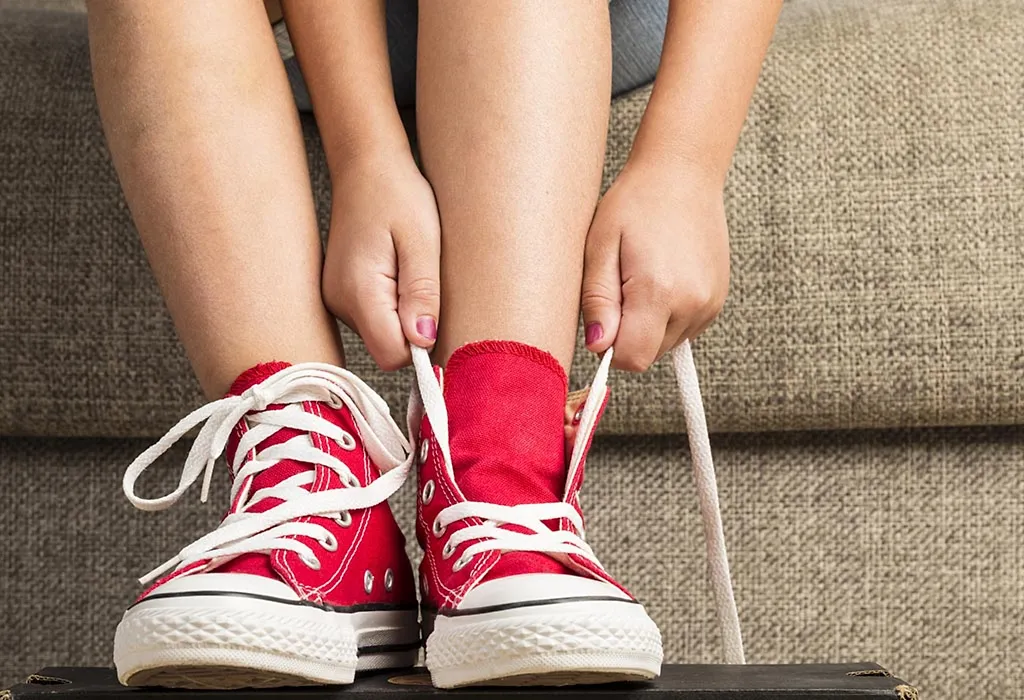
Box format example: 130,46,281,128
89,0,343,397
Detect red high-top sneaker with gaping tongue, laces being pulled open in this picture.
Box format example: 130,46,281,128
411,341,662,688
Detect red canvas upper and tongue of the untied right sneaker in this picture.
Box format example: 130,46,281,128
417,341,630,607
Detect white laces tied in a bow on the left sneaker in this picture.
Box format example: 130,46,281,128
123,362,413,583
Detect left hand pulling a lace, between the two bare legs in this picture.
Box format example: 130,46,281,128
323,152,440,369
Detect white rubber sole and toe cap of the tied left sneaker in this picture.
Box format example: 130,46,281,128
114,594,419,689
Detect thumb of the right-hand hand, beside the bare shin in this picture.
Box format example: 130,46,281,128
581,217,623,353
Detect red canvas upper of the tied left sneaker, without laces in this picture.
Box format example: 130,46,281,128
142,362,416,606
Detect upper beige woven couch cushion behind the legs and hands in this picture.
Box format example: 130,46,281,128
0,0,1024,436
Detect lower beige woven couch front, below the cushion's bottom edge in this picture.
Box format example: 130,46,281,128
0,428,1024,700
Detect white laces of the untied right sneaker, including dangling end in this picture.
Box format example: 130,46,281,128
410,342,745,663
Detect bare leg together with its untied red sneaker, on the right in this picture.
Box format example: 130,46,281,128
417,12,662,688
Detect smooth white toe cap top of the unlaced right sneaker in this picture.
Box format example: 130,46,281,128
459,574,633,610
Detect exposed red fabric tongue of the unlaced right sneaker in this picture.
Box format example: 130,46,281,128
444,341,568,506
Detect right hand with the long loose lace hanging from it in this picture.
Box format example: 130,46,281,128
583,161,729,371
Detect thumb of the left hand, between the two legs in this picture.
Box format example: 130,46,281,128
394,227,441,348
